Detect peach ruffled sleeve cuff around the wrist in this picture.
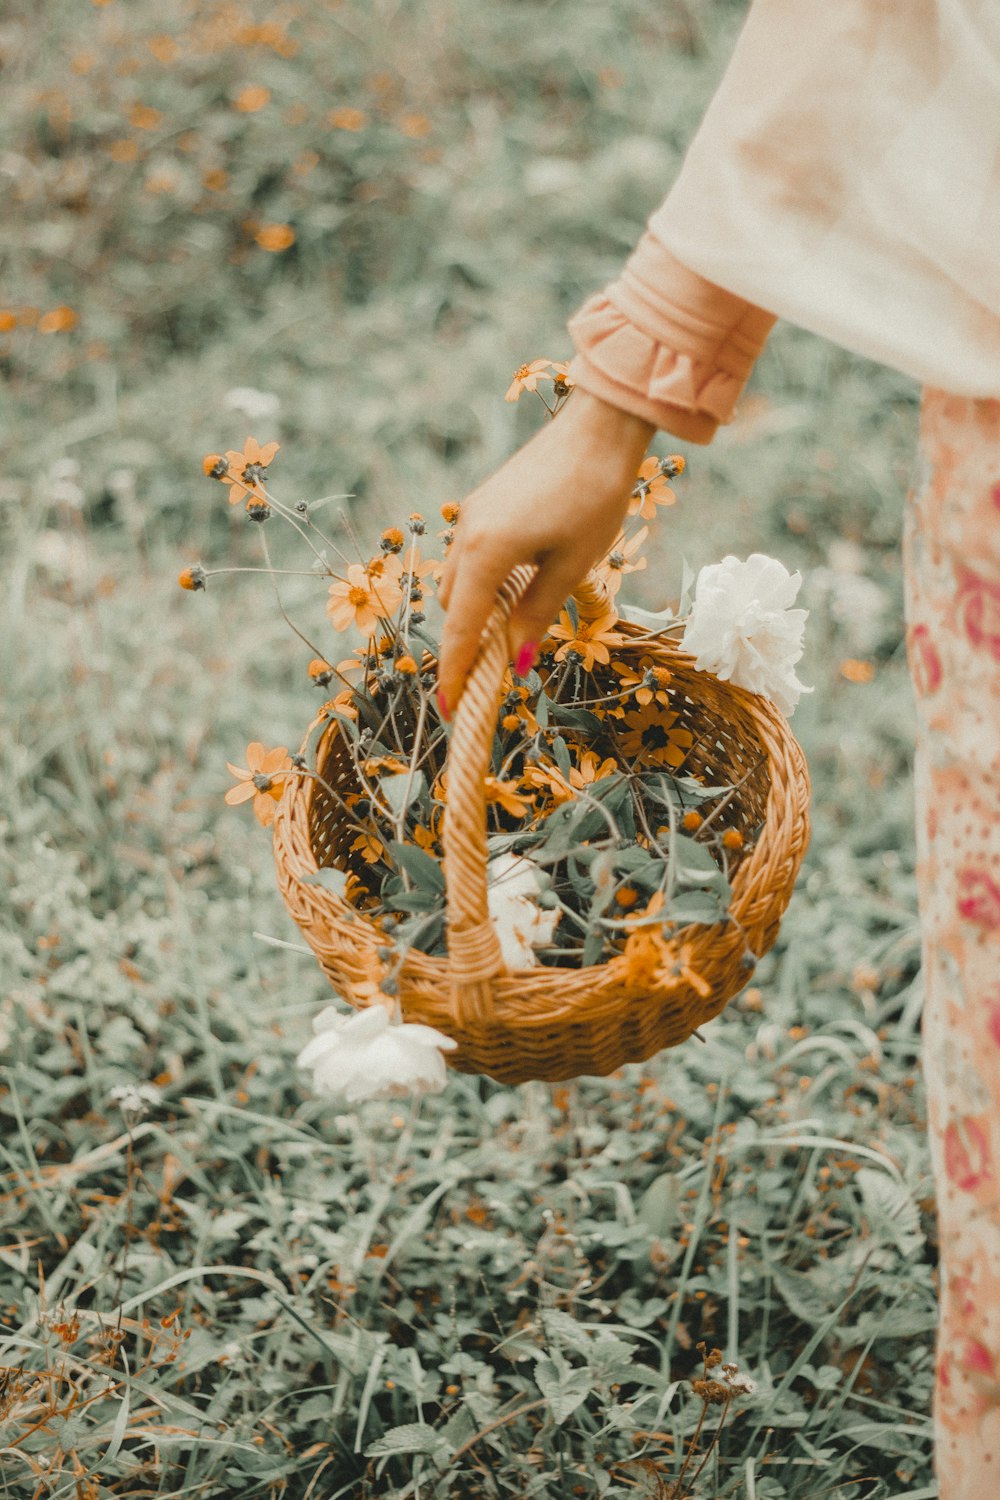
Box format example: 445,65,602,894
567,230,775,443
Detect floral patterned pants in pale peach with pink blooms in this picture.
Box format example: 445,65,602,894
903,389,1000,1500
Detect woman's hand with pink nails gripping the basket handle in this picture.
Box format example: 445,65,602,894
438,387,657,717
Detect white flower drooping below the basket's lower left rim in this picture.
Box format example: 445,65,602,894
295,1001,459,1104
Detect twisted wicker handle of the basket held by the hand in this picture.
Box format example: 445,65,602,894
444,566,610,1025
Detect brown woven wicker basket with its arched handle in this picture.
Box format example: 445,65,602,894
274,567,810,1083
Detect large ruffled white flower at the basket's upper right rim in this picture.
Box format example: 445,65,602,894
681,552,813,717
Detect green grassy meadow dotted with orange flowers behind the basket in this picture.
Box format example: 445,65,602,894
0,0,937,1500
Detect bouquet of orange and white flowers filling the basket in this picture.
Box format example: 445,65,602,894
180,360,808,1098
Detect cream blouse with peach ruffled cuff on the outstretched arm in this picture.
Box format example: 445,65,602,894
568,0,1000,443
